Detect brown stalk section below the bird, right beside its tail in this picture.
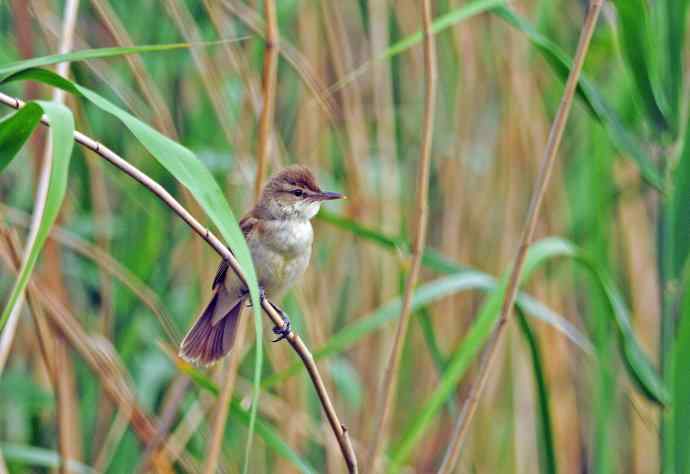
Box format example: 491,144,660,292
203,312,247,474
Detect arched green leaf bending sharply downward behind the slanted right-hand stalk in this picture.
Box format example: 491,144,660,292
384,238,668,471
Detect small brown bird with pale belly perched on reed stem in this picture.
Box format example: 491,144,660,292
180,166,345,365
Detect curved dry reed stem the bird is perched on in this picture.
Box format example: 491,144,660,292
0,92,358,472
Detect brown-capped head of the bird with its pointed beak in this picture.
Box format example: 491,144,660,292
259,165,345,220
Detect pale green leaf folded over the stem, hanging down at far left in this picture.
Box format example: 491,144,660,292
0,102,74,330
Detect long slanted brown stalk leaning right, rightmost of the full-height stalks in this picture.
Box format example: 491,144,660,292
439,0,603,474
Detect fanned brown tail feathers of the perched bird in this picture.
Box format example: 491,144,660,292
180,292,244,365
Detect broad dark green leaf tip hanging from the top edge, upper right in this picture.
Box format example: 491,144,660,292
612,0,668,129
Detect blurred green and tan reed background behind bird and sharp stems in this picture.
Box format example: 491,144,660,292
0,0,690,473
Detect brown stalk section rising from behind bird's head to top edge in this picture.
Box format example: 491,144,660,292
254,0,280,200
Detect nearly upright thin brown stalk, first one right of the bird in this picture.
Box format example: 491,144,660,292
367,0,436,472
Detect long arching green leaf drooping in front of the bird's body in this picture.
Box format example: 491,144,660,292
2,68,263,466
